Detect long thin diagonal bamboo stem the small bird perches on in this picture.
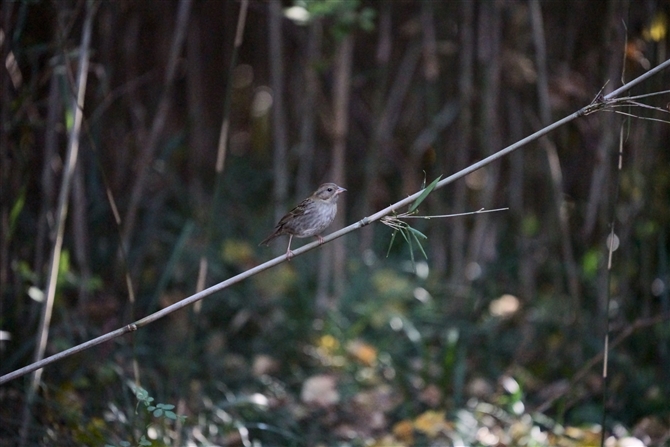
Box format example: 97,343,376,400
0,59,670,385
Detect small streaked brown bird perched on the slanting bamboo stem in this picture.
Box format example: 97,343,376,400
260,183,346,261
